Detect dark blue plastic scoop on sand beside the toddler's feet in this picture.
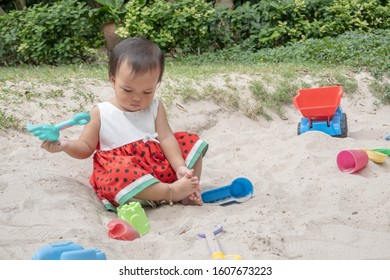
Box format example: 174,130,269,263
201,178,253,205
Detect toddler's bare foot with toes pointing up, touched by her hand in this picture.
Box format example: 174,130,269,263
172,170,200,201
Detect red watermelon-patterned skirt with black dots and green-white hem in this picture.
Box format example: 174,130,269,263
90,132,208,211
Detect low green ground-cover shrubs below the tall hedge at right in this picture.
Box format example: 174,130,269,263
252,29,390,76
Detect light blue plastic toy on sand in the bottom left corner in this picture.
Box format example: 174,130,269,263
32,241,107,260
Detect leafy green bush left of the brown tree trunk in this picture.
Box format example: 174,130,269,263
0,0,99,65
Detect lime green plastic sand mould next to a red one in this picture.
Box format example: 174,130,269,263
117,202,150,236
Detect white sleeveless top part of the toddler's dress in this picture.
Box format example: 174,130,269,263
97,98,159,151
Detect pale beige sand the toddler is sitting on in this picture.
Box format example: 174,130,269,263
0,73,390,260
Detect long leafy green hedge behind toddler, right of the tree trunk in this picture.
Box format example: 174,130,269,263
118,0,390,53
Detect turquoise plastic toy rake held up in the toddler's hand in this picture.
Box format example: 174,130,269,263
27,112,91,141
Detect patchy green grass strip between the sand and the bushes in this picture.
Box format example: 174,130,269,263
0,62,389,129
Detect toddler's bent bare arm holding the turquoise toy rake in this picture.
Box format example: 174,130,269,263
41,106,100,159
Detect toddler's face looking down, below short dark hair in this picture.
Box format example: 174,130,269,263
111,63,160,112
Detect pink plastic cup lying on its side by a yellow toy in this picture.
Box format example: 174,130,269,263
337,150,368,173
